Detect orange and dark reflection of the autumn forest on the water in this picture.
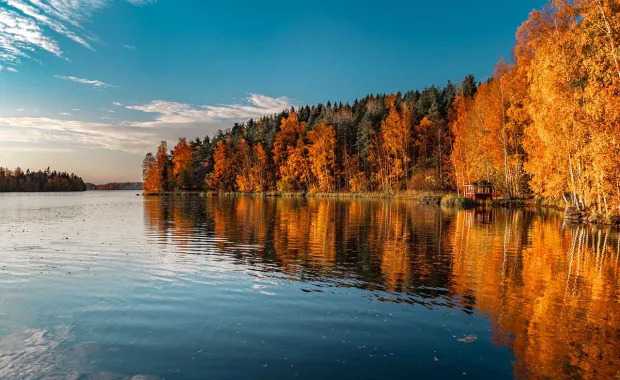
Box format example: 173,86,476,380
144,197,620,379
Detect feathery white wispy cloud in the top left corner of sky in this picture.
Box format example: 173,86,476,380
0,0,155,64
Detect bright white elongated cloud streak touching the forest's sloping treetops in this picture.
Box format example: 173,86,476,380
127,94,292,127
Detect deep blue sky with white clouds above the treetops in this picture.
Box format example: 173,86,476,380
0,0,545,183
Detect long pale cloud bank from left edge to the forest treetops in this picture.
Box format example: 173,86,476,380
0,94,292,155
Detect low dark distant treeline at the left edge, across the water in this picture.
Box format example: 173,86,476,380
0,167,86,192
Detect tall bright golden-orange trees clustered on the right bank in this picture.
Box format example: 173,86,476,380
451,0,620,219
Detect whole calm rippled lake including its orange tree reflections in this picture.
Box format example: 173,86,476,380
0,191,620,380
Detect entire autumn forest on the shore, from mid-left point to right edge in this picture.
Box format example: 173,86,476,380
143,0,620,220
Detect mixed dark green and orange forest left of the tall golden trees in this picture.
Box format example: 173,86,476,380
143,80,468,193
